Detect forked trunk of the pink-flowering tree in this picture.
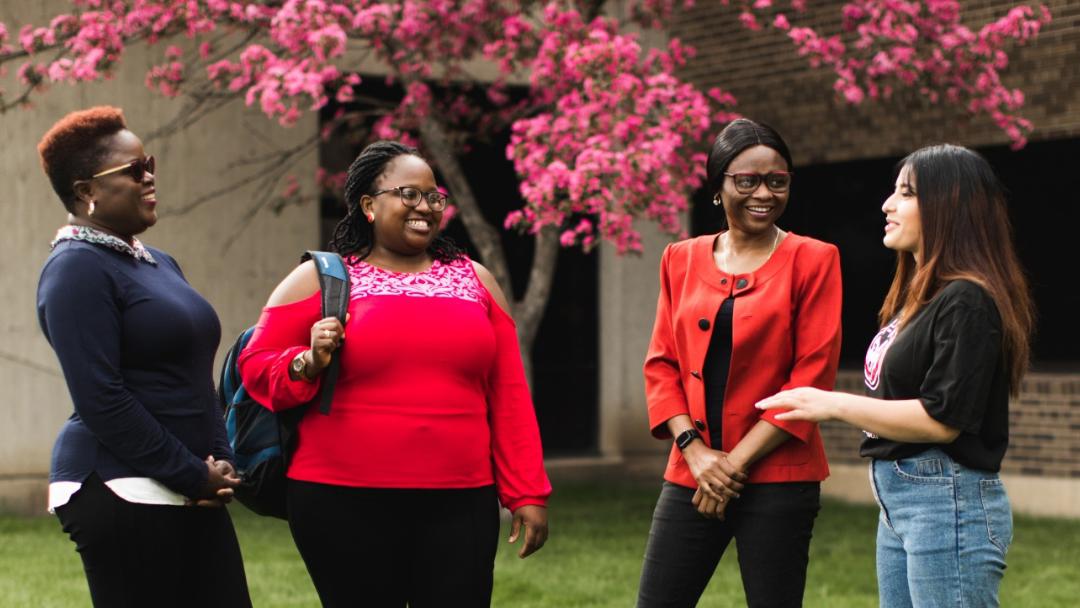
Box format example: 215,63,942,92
420,117,558,386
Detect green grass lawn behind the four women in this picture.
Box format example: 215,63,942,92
0,483,1080,608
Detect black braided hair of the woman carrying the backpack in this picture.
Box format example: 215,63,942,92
329,140,465,264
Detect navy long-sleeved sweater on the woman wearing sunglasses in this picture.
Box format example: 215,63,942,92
38,241,232,497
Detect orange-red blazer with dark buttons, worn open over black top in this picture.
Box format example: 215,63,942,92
645,233,841,488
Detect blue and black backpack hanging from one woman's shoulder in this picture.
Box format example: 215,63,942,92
218,252,349,519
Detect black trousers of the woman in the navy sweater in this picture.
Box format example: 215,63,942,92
56,474,252,608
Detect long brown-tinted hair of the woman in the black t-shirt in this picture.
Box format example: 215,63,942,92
878,145,1035,394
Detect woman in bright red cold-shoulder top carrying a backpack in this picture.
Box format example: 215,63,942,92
239,141,551,607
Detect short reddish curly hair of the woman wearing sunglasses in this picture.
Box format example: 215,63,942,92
38,106,127,211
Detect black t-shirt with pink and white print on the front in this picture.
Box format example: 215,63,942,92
860,281,1009,472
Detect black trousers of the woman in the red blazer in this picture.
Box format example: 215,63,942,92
637,482,821,608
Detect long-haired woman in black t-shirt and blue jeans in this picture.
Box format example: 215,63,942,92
757,145,1034,607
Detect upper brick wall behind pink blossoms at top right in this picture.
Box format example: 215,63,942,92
671,0,1080,165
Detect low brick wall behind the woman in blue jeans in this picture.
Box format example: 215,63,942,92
821,371,1080,479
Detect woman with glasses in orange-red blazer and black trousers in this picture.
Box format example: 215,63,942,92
637,119,841,608
